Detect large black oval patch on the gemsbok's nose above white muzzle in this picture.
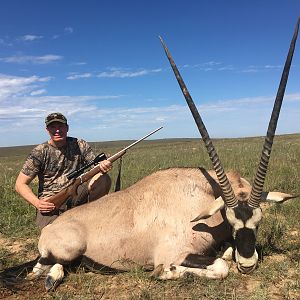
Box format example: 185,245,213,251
235,228,256,258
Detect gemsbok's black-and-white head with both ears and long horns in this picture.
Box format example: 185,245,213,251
160,18,300,274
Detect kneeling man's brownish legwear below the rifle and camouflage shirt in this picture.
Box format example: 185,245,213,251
36,182,89,230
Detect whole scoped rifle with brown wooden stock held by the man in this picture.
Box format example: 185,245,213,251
47,127,162,209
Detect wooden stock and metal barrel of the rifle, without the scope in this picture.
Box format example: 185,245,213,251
47,127,162,209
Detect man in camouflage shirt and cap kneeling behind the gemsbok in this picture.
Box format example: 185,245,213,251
15,113,112,229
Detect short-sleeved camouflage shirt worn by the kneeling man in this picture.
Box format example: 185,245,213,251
21,137,95,198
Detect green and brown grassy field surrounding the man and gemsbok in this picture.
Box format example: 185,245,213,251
0,134,300,300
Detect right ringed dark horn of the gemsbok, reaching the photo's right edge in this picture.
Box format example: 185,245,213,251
248,18,300,208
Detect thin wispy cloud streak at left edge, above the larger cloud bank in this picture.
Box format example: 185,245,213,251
0,54,63,64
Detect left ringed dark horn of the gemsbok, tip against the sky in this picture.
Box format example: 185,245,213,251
159,37,238,207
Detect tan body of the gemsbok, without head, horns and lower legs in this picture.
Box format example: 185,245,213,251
39,168,247,270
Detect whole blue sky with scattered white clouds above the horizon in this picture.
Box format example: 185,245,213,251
0,0,300,146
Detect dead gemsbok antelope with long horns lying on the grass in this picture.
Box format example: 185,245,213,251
28,19,300,290
